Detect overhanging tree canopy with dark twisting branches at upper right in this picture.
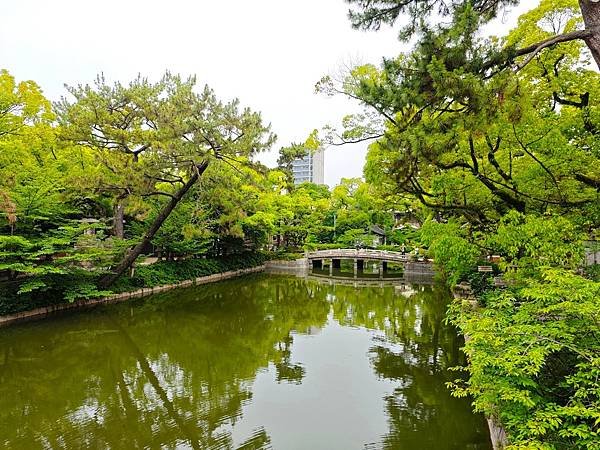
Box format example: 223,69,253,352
326,1,600,226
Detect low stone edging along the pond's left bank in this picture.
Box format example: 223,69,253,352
0,264,266,328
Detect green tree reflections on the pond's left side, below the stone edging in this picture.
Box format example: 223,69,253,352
0,272,329,449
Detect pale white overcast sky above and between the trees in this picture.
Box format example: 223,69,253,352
0,0,537,185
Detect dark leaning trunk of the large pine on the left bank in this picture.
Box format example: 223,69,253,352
99,161,208,288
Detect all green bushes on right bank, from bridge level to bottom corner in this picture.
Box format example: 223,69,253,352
423,212,600,449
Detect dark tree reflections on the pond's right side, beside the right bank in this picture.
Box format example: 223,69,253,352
333,286,489,449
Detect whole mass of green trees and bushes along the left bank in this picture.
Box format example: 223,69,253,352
0,71,398,314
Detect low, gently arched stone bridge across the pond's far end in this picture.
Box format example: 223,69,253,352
306,248,433,277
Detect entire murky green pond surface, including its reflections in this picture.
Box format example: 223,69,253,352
0,274,491,450
